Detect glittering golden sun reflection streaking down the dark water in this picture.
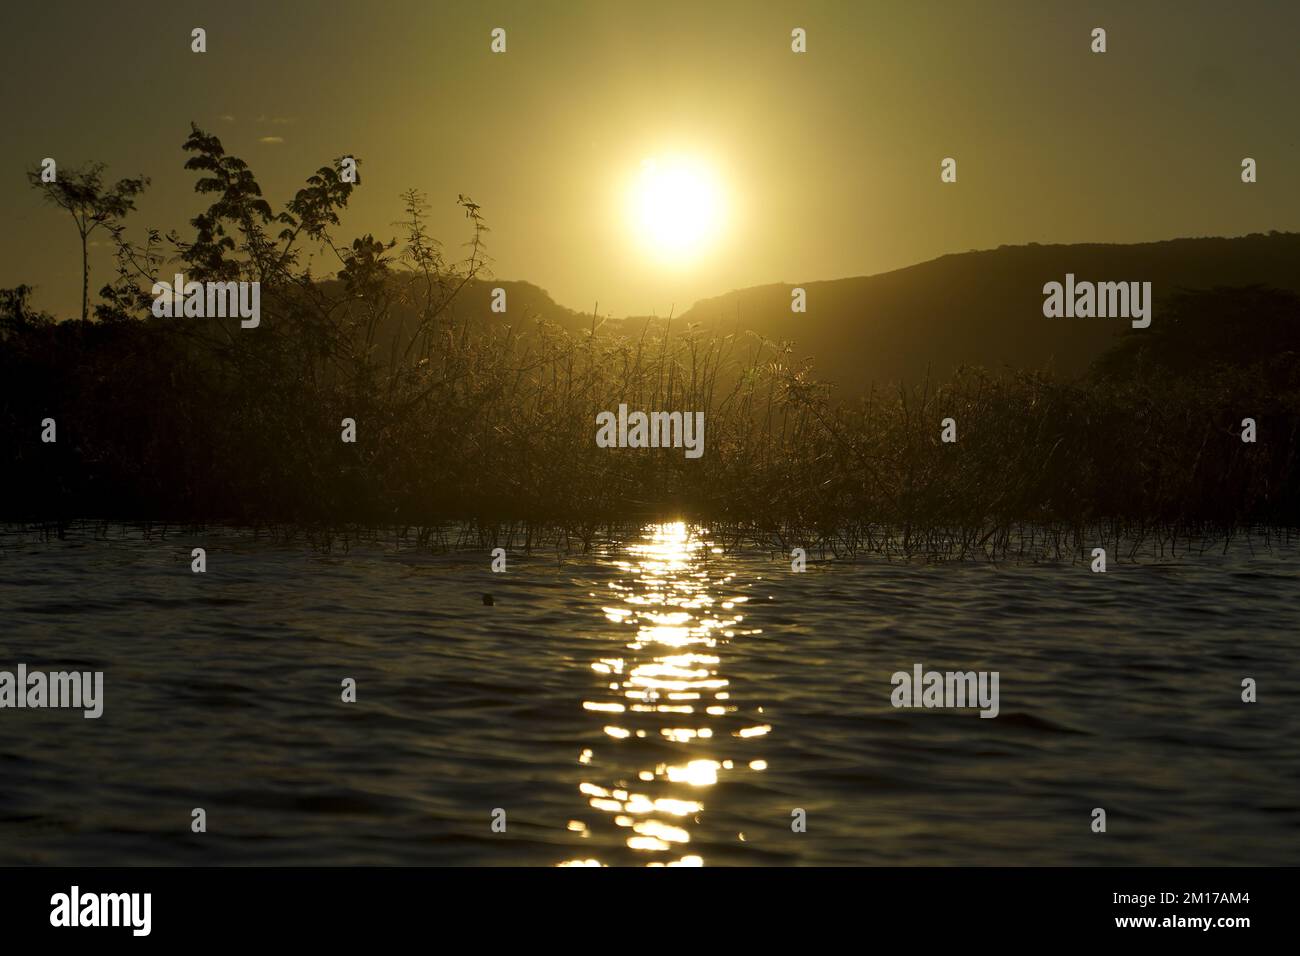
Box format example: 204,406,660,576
560,523,771,866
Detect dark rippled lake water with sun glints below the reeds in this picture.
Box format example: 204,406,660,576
0,525,1300,866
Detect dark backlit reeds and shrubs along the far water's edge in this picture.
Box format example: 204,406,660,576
0,127,1300,557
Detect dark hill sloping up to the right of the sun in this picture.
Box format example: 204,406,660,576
673,233,1300,397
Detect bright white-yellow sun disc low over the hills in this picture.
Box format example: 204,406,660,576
628,156,725,265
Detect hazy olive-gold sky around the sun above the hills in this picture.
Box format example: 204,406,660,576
0,0,1300,321
